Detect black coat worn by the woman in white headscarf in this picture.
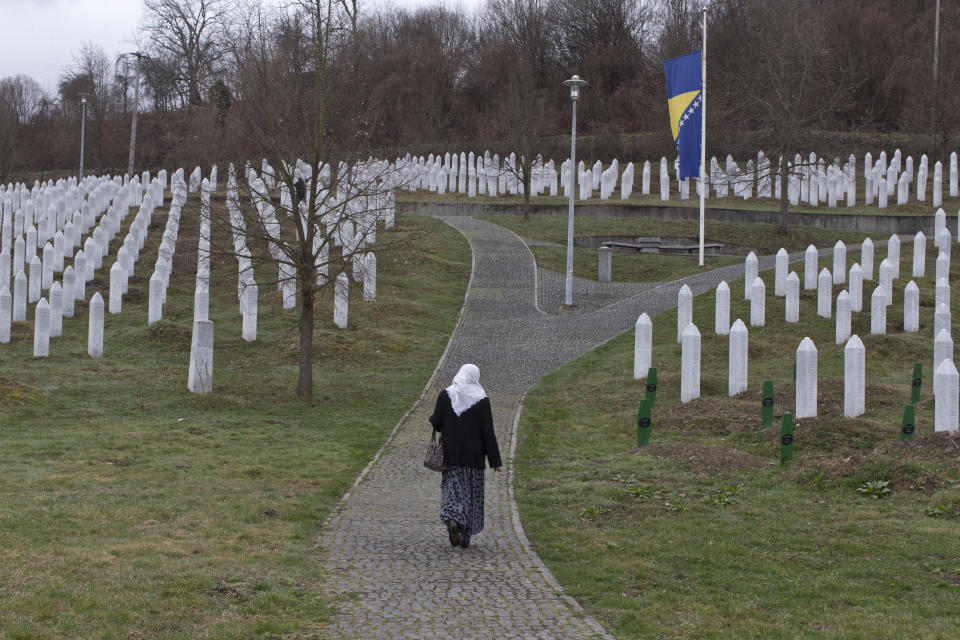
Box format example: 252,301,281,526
430,389,503,469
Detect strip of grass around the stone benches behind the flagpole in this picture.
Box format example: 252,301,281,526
483,215,885,282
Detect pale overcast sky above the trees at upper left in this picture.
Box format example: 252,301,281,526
0,0,472,92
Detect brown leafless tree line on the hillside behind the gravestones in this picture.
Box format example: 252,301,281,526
0,0,960,181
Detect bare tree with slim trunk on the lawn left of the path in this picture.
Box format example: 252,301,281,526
213,0,412,399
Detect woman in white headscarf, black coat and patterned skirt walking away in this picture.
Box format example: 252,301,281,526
430,364,503,549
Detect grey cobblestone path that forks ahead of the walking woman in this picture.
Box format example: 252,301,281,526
318,217,829,640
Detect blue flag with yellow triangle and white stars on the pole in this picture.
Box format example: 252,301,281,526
663,51,703,180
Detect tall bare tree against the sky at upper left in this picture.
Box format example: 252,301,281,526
144,0,227,106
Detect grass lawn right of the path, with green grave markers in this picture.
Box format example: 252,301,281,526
516,232,960,639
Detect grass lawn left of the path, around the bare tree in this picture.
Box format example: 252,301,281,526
0,208,470,639
